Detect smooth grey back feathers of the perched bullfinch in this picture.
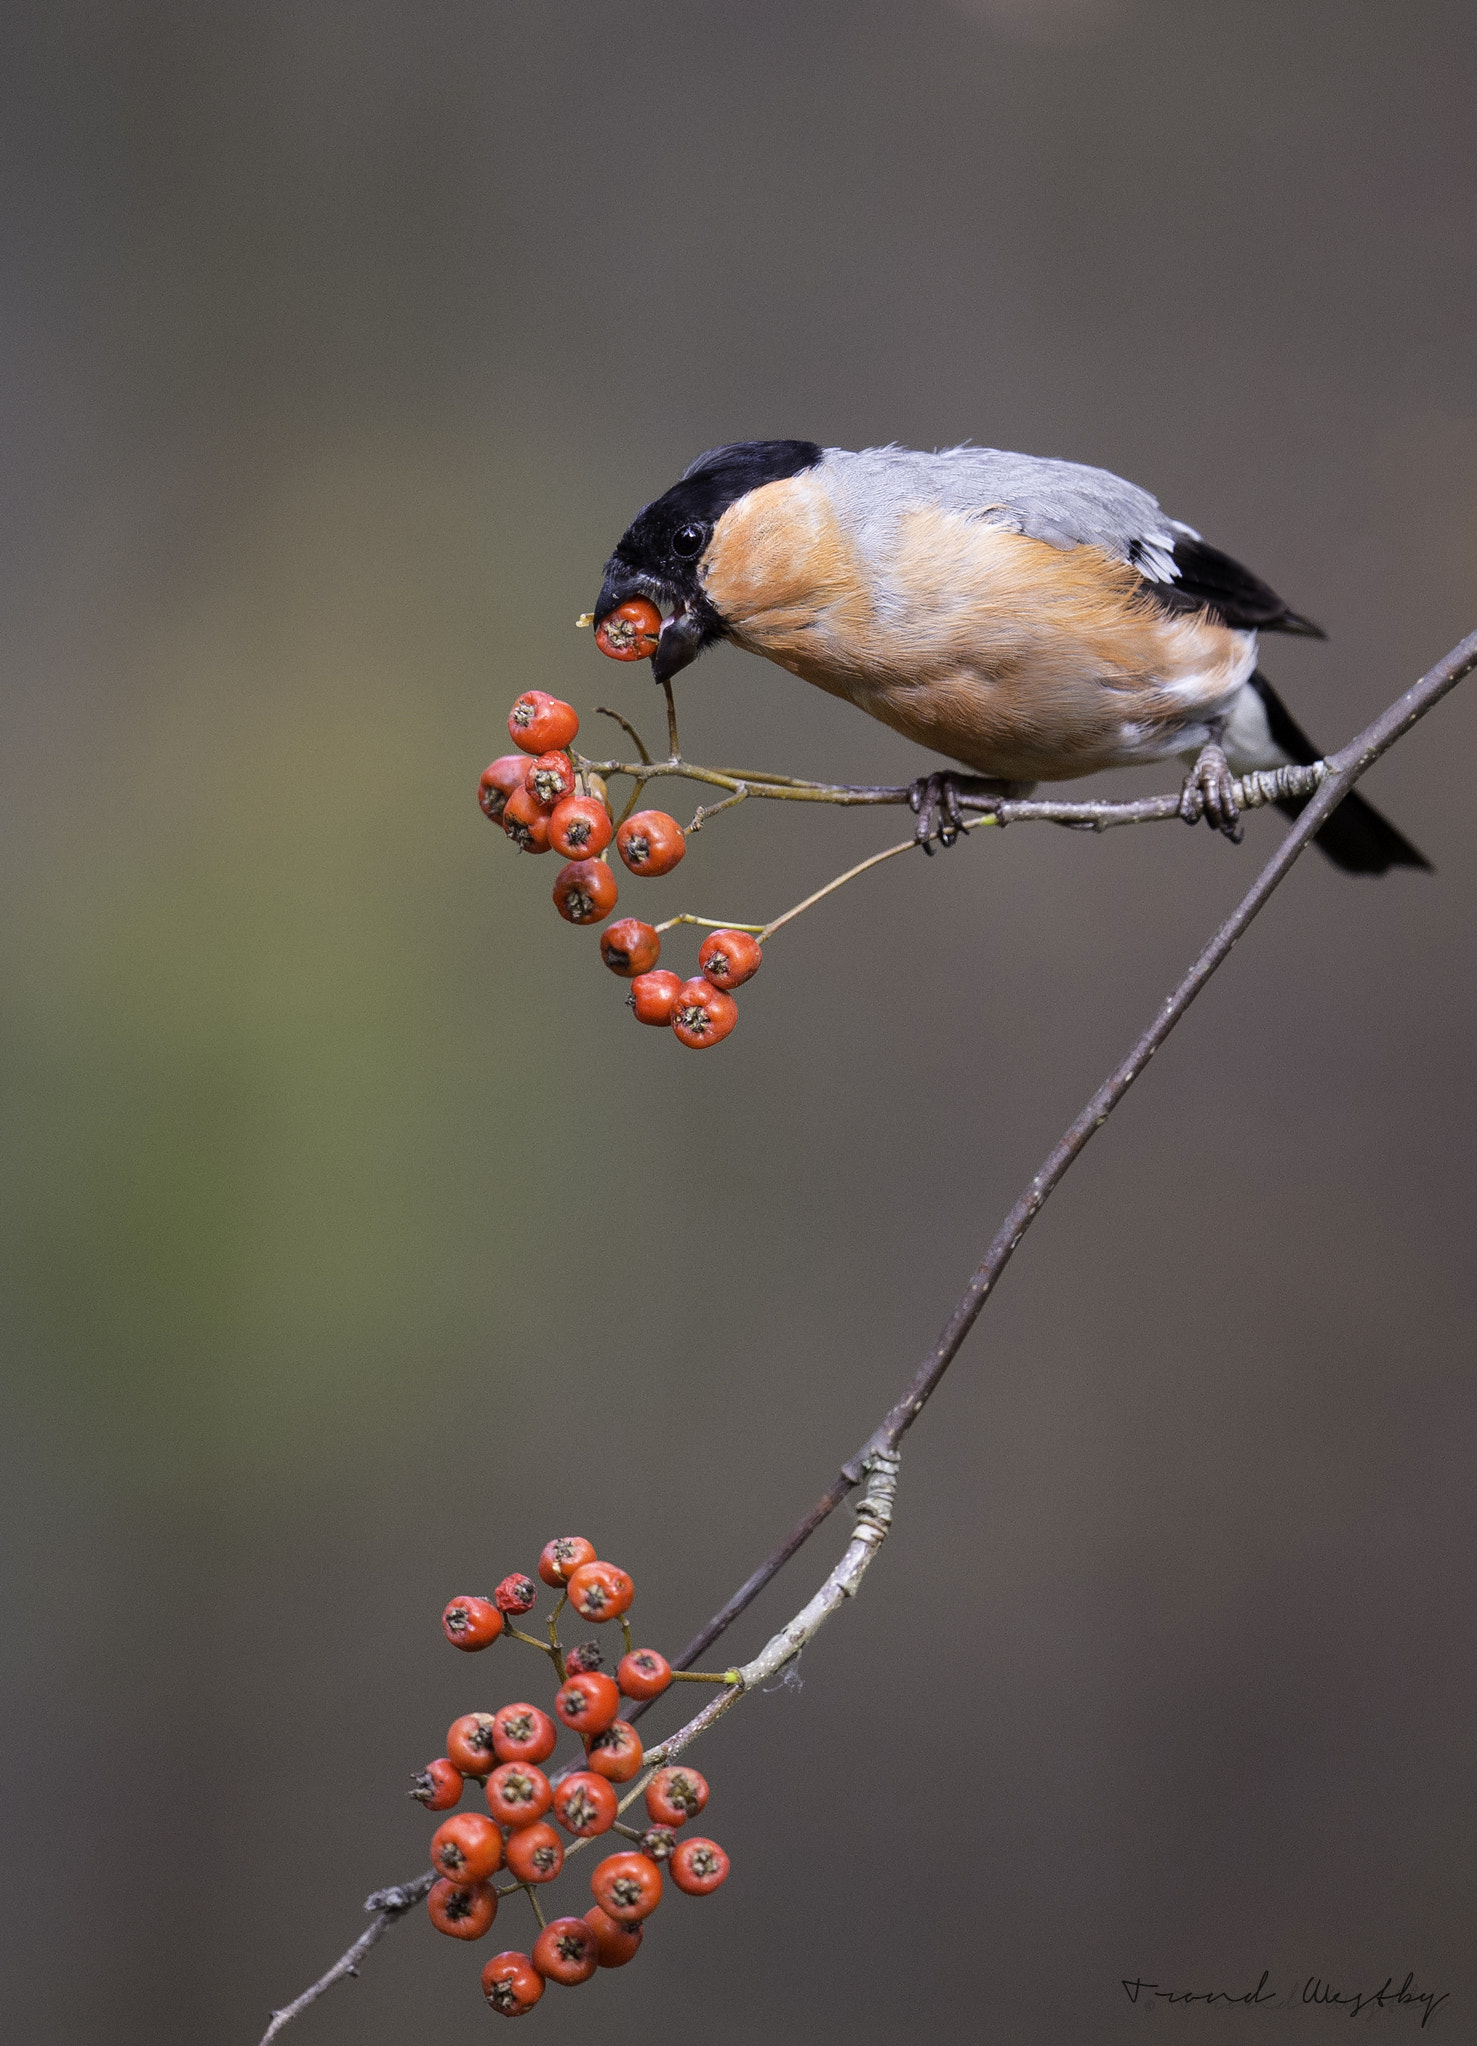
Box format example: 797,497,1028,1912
820,446,1199,583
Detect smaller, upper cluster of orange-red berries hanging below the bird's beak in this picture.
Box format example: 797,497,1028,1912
477,675,763,1052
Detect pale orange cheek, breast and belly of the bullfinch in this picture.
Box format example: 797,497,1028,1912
704,469,1256,782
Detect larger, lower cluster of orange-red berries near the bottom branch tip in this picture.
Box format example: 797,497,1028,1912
411,1535,728,2017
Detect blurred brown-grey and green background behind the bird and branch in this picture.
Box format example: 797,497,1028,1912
0,0,1477,2046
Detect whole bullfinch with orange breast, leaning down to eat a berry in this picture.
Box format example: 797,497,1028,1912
591,440,1430,874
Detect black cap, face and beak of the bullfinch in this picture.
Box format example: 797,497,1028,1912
595,440,822,681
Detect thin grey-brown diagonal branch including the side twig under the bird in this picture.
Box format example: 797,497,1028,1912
262,632,1477,2046
